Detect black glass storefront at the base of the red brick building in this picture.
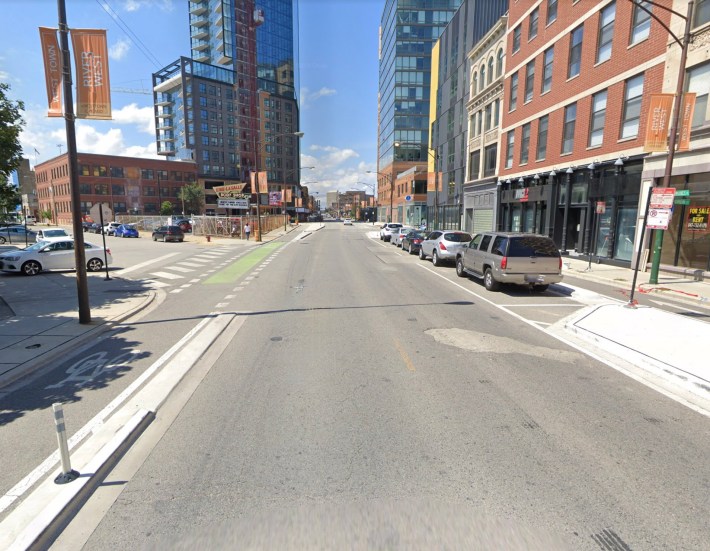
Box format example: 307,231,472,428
498,158,643,266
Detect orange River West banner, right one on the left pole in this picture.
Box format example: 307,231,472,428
70,29,111,120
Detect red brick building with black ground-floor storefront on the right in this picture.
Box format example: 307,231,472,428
498,0,672,263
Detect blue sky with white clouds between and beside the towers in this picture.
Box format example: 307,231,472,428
0,0,384,199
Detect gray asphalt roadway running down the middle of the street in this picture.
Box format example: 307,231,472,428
54,225,710,550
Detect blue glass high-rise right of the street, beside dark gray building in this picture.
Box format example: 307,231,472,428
377,0,462,224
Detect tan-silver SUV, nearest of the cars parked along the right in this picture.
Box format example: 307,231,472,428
456,232,562,292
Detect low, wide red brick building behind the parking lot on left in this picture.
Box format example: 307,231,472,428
35,153,196,225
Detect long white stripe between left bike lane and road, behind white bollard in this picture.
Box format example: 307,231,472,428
0,316,213,513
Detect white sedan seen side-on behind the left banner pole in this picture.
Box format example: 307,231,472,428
0,238,113,275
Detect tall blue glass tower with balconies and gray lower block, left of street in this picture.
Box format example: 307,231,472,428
153,0,299,216
